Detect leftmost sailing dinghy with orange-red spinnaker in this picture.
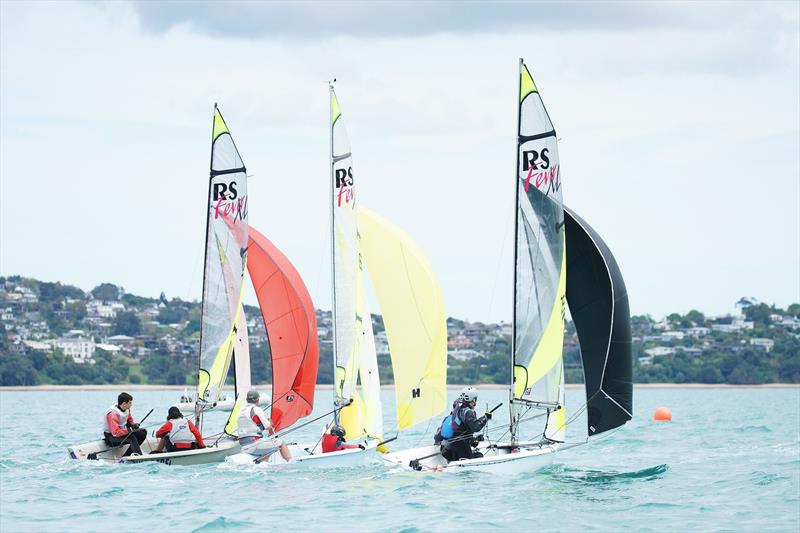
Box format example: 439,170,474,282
69,105,317,465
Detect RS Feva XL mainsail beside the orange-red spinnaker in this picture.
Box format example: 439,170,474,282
197,105,248,403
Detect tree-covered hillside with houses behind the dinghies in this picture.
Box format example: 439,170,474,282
0,276,800,386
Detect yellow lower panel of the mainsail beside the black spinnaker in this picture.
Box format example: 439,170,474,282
514,241,567,400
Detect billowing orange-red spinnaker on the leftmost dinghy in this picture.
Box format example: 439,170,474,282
247,226,319,431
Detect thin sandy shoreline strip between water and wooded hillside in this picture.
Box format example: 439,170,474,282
0,383,800,392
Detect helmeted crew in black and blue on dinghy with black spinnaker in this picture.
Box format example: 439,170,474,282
433,387,492,461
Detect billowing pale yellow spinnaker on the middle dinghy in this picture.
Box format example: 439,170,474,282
358,206,447,429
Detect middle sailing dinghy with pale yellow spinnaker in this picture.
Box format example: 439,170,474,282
268,85,447,467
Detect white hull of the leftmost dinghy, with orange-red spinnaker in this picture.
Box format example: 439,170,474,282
67,437,241,465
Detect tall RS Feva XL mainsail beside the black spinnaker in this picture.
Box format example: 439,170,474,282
511,60,566,440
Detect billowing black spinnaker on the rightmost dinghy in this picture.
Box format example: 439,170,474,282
564,207,633,436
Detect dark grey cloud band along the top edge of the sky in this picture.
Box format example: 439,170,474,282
128,0,796,39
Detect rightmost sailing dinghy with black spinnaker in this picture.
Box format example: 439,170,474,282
383,60,633,473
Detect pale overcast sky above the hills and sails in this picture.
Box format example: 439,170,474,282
0,0,800,321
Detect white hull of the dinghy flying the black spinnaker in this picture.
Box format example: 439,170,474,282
382,442,560,474
